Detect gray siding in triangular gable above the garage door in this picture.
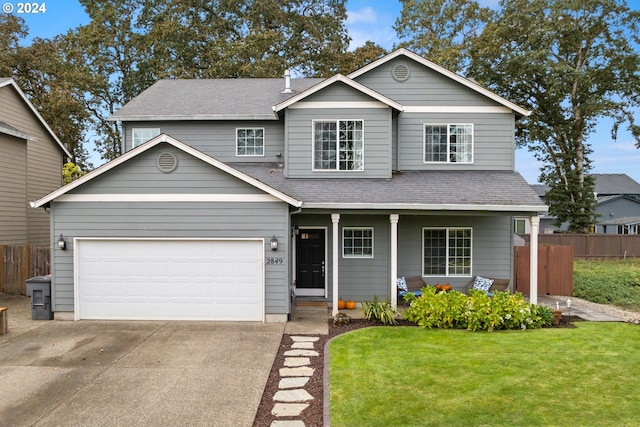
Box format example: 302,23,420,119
72,143,264,194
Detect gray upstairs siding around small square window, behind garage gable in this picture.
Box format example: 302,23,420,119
123,120,284,163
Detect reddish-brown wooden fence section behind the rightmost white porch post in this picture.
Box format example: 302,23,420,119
513,245,573,296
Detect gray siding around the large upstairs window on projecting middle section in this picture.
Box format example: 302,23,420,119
285,108,392,178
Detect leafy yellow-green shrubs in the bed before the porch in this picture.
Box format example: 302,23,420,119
404,286,553,331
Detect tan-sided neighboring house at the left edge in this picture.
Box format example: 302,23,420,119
0,78,71,246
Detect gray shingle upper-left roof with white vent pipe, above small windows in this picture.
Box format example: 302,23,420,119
109,78,324,121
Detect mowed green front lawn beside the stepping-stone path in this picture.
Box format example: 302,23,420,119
329,322,640,427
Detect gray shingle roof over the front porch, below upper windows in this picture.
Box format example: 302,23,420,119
231,164,545,210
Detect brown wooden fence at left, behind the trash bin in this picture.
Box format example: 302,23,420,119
0,245,50,295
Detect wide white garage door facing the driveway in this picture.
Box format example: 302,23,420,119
75,239,264,321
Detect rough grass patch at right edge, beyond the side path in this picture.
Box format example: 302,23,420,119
573,258,640,310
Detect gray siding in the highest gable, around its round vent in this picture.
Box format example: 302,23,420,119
356,58,498,106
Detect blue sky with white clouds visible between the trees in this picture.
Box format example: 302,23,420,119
8,0,640,184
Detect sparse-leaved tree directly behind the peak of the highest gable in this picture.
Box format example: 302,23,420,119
394,0,494,73
